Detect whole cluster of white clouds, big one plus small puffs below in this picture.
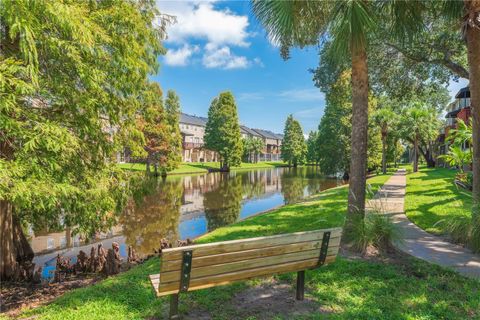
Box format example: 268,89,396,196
157,0,263,69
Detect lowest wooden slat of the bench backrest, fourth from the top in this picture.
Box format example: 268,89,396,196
152,255,336,296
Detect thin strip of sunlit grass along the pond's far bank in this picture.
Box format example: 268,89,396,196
118,161,286,174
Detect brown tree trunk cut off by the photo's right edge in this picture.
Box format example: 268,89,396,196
465,0,480,251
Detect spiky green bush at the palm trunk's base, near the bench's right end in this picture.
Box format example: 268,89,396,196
352,211,401,253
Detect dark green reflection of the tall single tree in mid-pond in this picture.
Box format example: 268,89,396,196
203,173,242,231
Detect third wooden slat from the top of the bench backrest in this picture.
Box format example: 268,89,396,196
160,247,338,284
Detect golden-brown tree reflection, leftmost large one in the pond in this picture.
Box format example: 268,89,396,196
120,178,183,254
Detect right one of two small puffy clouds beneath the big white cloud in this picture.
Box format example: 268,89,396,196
202,45,249,69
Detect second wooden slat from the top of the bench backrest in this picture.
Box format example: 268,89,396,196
161,237,340,274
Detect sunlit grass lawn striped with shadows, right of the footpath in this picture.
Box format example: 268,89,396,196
405,167,472,234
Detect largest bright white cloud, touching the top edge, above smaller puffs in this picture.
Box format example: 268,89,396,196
157,1,249,47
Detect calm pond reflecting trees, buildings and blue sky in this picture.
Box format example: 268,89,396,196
31,166,343,278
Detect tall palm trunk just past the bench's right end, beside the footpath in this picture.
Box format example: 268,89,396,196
345,47,368,241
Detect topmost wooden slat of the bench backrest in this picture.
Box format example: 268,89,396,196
162,228,342,261
